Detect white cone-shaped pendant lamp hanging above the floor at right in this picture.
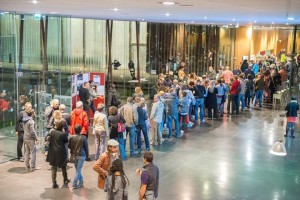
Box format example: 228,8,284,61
269,114,287,156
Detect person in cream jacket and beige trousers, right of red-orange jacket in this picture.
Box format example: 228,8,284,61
93,104,110,160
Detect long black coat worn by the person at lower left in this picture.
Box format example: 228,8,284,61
46,129,68,167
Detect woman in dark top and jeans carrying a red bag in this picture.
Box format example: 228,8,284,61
108,106,126,159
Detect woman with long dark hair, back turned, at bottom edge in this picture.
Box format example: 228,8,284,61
104,159,129,200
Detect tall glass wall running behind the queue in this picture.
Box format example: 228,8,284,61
0,11,300,162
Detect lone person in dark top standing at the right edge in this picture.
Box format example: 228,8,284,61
284,96,299,138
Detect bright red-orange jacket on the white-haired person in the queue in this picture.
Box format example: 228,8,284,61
70,108,89,135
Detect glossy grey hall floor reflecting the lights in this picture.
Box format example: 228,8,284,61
0,108,300,200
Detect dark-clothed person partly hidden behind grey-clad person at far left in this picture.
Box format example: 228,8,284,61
16,102,32,162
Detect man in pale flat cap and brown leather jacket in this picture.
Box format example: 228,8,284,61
93,139,119,189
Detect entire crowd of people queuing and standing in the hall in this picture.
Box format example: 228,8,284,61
12,51,299,199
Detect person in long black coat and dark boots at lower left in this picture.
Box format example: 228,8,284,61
46,120,71,189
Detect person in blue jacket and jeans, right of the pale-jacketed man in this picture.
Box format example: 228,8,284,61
165,92,180,138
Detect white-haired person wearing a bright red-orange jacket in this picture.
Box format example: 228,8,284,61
69,101,91,161
